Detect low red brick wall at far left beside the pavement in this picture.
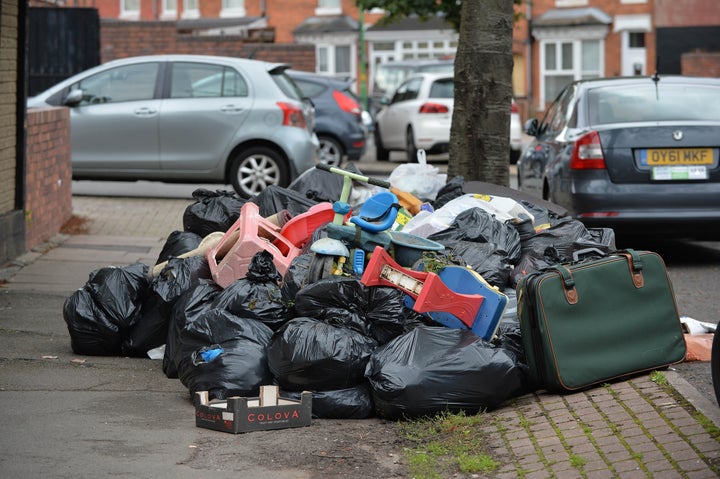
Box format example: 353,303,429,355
25,108,72,251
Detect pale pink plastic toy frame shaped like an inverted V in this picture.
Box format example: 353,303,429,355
207,201,300,288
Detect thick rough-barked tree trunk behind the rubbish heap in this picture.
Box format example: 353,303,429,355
448,0,513,186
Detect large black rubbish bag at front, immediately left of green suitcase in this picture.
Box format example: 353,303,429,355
365,327,527,419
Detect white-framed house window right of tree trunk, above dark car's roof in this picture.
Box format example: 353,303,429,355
540,40,604,102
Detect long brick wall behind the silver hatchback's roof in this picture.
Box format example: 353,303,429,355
100,19,315,71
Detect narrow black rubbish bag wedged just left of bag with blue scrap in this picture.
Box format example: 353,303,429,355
163,280,222,379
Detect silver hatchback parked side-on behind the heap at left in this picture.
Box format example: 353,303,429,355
27,55,319,198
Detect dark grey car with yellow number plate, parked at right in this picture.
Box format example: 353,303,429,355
518,76,720,240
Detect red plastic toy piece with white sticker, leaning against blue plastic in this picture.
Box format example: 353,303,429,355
360,246,485,328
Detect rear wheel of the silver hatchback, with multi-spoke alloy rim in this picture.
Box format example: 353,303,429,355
230,146,289,198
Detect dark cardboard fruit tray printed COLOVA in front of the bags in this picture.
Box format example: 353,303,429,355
194,386,312,434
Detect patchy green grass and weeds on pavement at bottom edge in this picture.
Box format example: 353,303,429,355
398,412,500,479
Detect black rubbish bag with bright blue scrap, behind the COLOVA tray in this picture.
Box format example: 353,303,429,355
178,309,273,399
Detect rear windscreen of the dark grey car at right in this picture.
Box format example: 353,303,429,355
588,83,720,125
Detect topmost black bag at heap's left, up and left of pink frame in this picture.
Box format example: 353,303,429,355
183,188,246,238
